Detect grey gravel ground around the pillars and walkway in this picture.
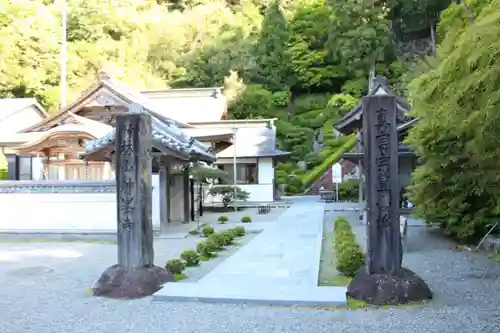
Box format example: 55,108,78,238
0,205,500,333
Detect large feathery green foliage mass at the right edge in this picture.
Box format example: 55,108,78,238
407,1,500,241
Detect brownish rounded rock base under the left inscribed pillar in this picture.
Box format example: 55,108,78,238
92,265,174,299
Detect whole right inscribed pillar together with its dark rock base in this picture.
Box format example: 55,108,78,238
347,95,432,305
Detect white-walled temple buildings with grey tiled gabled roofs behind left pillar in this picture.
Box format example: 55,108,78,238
0,73,288,226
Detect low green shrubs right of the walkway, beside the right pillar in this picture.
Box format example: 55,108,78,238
334,216,365,276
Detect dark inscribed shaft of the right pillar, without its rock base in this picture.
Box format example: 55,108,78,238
363,96,401,274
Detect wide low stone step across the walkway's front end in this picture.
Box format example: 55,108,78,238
153,282,347,306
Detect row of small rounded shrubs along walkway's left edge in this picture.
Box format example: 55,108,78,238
165,225,246,280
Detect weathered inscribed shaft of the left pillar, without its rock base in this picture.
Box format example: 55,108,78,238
116,114,154,268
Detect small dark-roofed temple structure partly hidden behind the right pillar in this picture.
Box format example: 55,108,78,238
335,76,418,203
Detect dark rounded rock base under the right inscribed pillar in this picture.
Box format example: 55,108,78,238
346,267,432,305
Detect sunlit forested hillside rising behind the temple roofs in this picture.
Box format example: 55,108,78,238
0,0,449,193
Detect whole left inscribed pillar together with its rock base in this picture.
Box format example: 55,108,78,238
93,111,172,298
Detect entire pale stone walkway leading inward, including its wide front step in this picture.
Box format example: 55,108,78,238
155,197,346,305
